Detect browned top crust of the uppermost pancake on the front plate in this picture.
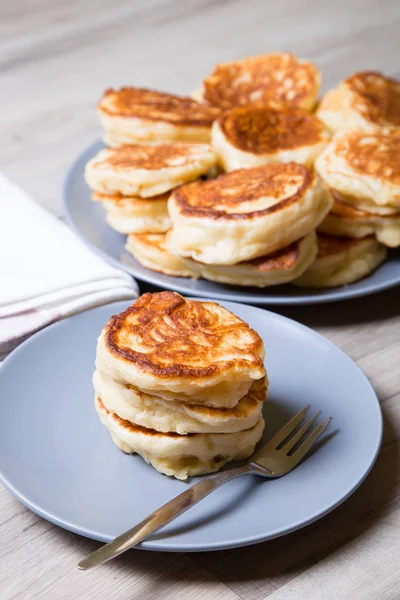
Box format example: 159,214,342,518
105,292,263,378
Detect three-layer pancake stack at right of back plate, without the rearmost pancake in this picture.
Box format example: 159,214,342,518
297,130,400,287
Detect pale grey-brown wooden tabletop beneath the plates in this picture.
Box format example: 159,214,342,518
0,0,400,600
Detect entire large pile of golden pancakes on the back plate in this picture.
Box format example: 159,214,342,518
86,53,400,287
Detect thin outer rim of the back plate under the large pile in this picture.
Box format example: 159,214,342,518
62,138,400,306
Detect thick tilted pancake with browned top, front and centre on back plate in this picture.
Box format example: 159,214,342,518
167,163,332,265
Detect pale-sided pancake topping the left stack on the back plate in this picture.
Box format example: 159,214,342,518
85,142,216,198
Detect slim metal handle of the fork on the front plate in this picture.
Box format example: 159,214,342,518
78,465,250,569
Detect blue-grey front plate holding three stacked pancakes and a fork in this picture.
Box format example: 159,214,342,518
0,302,382,551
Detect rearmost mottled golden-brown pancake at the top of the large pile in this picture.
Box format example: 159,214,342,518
193,52,321,110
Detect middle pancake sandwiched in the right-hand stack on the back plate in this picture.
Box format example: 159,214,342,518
318,190,400,248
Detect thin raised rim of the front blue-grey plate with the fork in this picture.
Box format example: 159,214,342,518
0,298,383,552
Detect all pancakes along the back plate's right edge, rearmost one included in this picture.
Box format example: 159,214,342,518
296,71,400,287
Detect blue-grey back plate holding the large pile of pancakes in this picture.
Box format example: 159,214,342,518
64,142,400,304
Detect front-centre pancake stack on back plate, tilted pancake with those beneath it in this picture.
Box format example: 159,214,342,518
141,163,332,287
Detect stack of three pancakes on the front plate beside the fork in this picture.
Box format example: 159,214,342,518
93,292,268,479
